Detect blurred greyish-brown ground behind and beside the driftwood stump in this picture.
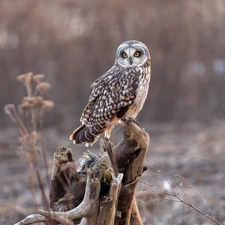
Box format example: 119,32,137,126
0,121,225,225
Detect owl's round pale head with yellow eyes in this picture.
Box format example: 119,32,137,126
116,40,150,67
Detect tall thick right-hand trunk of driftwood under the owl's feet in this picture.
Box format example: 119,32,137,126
113,119,150,225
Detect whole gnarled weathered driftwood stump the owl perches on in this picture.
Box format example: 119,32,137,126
16,119,150,225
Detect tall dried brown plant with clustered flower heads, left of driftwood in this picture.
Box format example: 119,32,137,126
5,73,54,210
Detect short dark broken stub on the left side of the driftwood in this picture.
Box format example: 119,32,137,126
49,147,86,211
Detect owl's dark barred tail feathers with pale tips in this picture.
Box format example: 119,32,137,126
70,124,106,147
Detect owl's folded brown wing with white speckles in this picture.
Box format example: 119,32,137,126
81,67,139,126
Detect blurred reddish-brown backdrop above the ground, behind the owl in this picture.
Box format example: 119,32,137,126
0,0,225,130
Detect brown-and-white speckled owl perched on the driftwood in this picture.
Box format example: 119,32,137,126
70,40,151,146
